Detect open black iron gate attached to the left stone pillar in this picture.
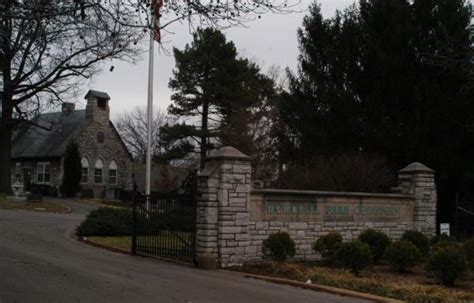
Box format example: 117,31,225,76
132,172,196,263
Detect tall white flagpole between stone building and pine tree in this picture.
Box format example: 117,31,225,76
145,12,155,210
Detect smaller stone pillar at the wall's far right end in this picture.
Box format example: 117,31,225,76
398,162,437,237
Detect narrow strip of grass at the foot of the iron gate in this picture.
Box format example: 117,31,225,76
87,232,191,251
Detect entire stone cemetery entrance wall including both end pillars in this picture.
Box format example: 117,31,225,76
196,147,436,267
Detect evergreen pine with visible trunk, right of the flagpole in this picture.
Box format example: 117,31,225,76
161,28,273,167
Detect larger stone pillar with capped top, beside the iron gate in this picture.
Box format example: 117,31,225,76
196,147,251,267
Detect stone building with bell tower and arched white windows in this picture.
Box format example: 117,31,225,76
11,90,132,198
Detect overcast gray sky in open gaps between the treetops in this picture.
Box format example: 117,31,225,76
83,0,354,119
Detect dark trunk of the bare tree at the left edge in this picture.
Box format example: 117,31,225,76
0,94,13,194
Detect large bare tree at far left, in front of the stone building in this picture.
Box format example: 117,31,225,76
0,0,143,192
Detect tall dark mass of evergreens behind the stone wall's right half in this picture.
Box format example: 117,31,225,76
280,0,474,220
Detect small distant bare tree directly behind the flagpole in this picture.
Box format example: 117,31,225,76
115,106,171,162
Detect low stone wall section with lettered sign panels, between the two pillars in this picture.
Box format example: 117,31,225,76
248,189,415,259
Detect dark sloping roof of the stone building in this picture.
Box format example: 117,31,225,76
12,110,88,159
